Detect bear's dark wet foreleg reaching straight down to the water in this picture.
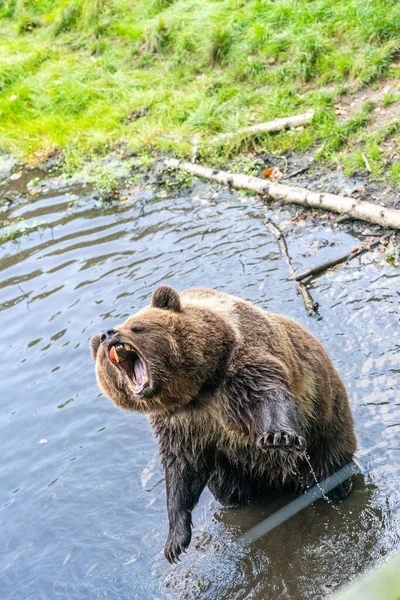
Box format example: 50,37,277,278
163,455,209,563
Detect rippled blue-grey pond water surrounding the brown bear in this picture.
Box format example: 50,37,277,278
0,170,400,600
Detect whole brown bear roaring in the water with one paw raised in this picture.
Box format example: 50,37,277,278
91,285,356,562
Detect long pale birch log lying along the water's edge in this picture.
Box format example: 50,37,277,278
165,158,400,229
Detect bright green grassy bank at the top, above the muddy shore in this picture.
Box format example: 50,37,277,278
0,0,400,180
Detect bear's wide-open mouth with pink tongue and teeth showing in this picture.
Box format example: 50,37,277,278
109,343,149,395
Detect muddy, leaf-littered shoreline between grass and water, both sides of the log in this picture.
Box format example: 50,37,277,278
0,149,400,266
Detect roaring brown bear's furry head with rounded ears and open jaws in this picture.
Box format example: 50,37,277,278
90,285,235,413
